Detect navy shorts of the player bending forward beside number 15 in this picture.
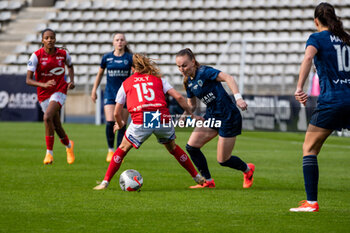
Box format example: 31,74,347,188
204,109,242,138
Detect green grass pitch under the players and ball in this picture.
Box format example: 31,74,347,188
0,122,350,233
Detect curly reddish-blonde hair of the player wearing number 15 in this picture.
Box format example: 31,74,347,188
132,53,162,78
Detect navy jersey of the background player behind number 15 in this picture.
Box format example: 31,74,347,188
100,52,132,100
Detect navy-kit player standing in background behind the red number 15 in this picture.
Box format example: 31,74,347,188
91,33,132,162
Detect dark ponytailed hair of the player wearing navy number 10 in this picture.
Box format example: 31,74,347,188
314,2,350,45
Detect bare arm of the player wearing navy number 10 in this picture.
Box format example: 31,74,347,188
294,45,317,105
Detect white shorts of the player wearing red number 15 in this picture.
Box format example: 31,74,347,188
125,122,176,149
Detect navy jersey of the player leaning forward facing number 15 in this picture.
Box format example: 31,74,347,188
186,66,238,118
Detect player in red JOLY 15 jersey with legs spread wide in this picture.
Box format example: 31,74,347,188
94,54,205,190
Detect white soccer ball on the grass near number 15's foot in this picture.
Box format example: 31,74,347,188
119,169,143,192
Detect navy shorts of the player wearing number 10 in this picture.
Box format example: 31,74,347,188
310,104,350,130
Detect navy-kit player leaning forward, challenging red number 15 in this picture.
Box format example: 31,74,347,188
176,49,255,188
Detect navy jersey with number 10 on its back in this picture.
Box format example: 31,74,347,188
306,31,350,104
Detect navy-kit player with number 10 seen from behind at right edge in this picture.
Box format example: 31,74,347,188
290,3,350,212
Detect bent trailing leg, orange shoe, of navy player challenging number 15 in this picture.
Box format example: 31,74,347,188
217,136,255,188
